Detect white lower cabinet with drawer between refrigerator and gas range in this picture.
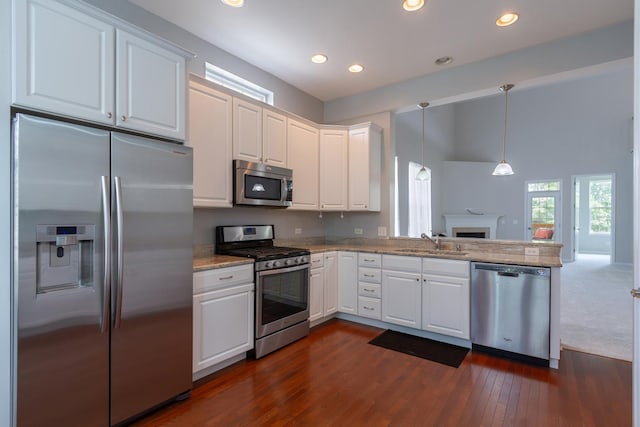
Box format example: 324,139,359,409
193,264,255,378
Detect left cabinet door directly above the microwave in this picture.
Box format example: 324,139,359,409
233,98,262,162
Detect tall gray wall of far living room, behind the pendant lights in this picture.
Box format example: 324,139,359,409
443,66,633,263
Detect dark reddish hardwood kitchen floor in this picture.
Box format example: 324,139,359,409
135,320,631,427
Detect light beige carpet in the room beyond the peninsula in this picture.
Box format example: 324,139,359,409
560,254,633,361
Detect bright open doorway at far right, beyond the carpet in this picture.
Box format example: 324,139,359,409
572,174,615,263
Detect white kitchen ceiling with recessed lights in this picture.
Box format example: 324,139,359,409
130,0,633,101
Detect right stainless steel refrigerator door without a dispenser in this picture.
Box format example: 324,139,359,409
111,133,193,424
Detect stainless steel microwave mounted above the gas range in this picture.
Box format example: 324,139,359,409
233,160,293,208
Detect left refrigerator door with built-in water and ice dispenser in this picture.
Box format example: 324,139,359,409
13,114,109,426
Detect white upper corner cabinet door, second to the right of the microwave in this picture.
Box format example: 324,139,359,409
318,129,349,211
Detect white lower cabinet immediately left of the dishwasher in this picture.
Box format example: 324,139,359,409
422,258,471,340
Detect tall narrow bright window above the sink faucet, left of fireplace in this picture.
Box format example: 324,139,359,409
409,162,431,237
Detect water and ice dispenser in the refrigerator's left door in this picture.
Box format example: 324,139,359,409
36,225,96,293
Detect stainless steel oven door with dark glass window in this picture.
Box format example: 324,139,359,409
256,264,309,338
